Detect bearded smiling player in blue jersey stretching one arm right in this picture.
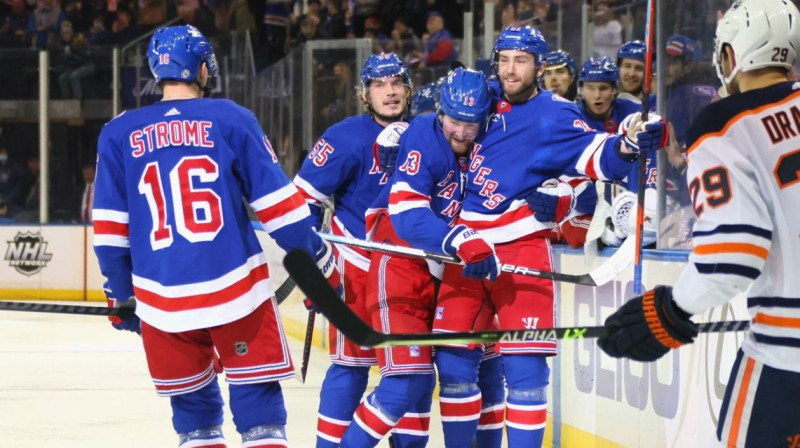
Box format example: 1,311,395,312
433,27,663,448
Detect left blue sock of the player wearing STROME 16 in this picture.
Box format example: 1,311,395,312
169,377,225,434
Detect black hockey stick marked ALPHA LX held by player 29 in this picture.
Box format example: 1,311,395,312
283,250,750,347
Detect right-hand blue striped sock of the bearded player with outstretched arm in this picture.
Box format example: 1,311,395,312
502,355,550,448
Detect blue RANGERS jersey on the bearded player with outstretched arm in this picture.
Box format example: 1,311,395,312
458,91,631,243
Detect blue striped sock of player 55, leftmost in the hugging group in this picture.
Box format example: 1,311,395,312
317,364,369,448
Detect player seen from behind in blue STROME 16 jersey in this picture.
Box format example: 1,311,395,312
93,26,340,448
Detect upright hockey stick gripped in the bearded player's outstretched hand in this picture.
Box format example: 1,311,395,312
633,0,667,295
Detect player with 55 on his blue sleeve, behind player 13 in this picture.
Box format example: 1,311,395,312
294,53,412,448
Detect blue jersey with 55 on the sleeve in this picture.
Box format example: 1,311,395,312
294,114,388,270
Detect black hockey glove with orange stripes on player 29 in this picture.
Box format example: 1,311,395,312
597,286,697,361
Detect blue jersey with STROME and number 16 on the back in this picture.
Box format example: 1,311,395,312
93,99,321,332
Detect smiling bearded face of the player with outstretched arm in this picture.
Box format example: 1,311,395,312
497,50,544,104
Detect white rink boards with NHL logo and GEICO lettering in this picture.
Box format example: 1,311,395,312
0,225,747,448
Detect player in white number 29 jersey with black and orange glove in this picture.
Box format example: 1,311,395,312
598,0,800,448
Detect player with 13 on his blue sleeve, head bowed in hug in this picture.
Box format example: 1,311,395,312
342,68,502,448
